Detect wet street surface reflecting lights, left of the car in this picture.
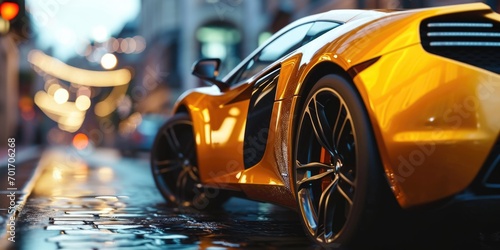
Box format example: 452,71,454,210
16,150,317,249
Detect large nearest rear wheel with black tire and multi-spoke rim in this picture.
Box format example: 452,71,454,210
294,75,394,248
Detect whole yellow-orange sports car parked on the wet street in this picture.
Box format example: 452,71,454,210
151,3,500,247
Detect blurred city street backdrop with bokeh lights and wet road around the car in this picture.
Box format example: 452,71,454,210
0,0,500,249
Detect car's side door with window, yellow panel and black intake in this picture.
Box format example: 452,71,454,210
202,22,338,183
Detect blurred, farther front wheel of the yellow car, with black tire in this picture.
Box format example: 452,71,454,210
151,113,229,210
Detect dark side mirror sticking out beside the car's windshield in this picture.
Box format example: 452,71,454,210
192,58,228,91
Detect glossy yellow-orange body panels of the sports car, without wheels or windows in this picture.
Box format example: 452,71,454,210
171,3,500,207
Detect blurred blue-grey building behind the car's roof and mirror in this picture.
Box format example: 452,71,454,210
137,0,500,94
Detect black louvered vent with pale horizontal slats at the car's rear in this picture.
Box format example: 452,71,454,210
420,12,500,74
